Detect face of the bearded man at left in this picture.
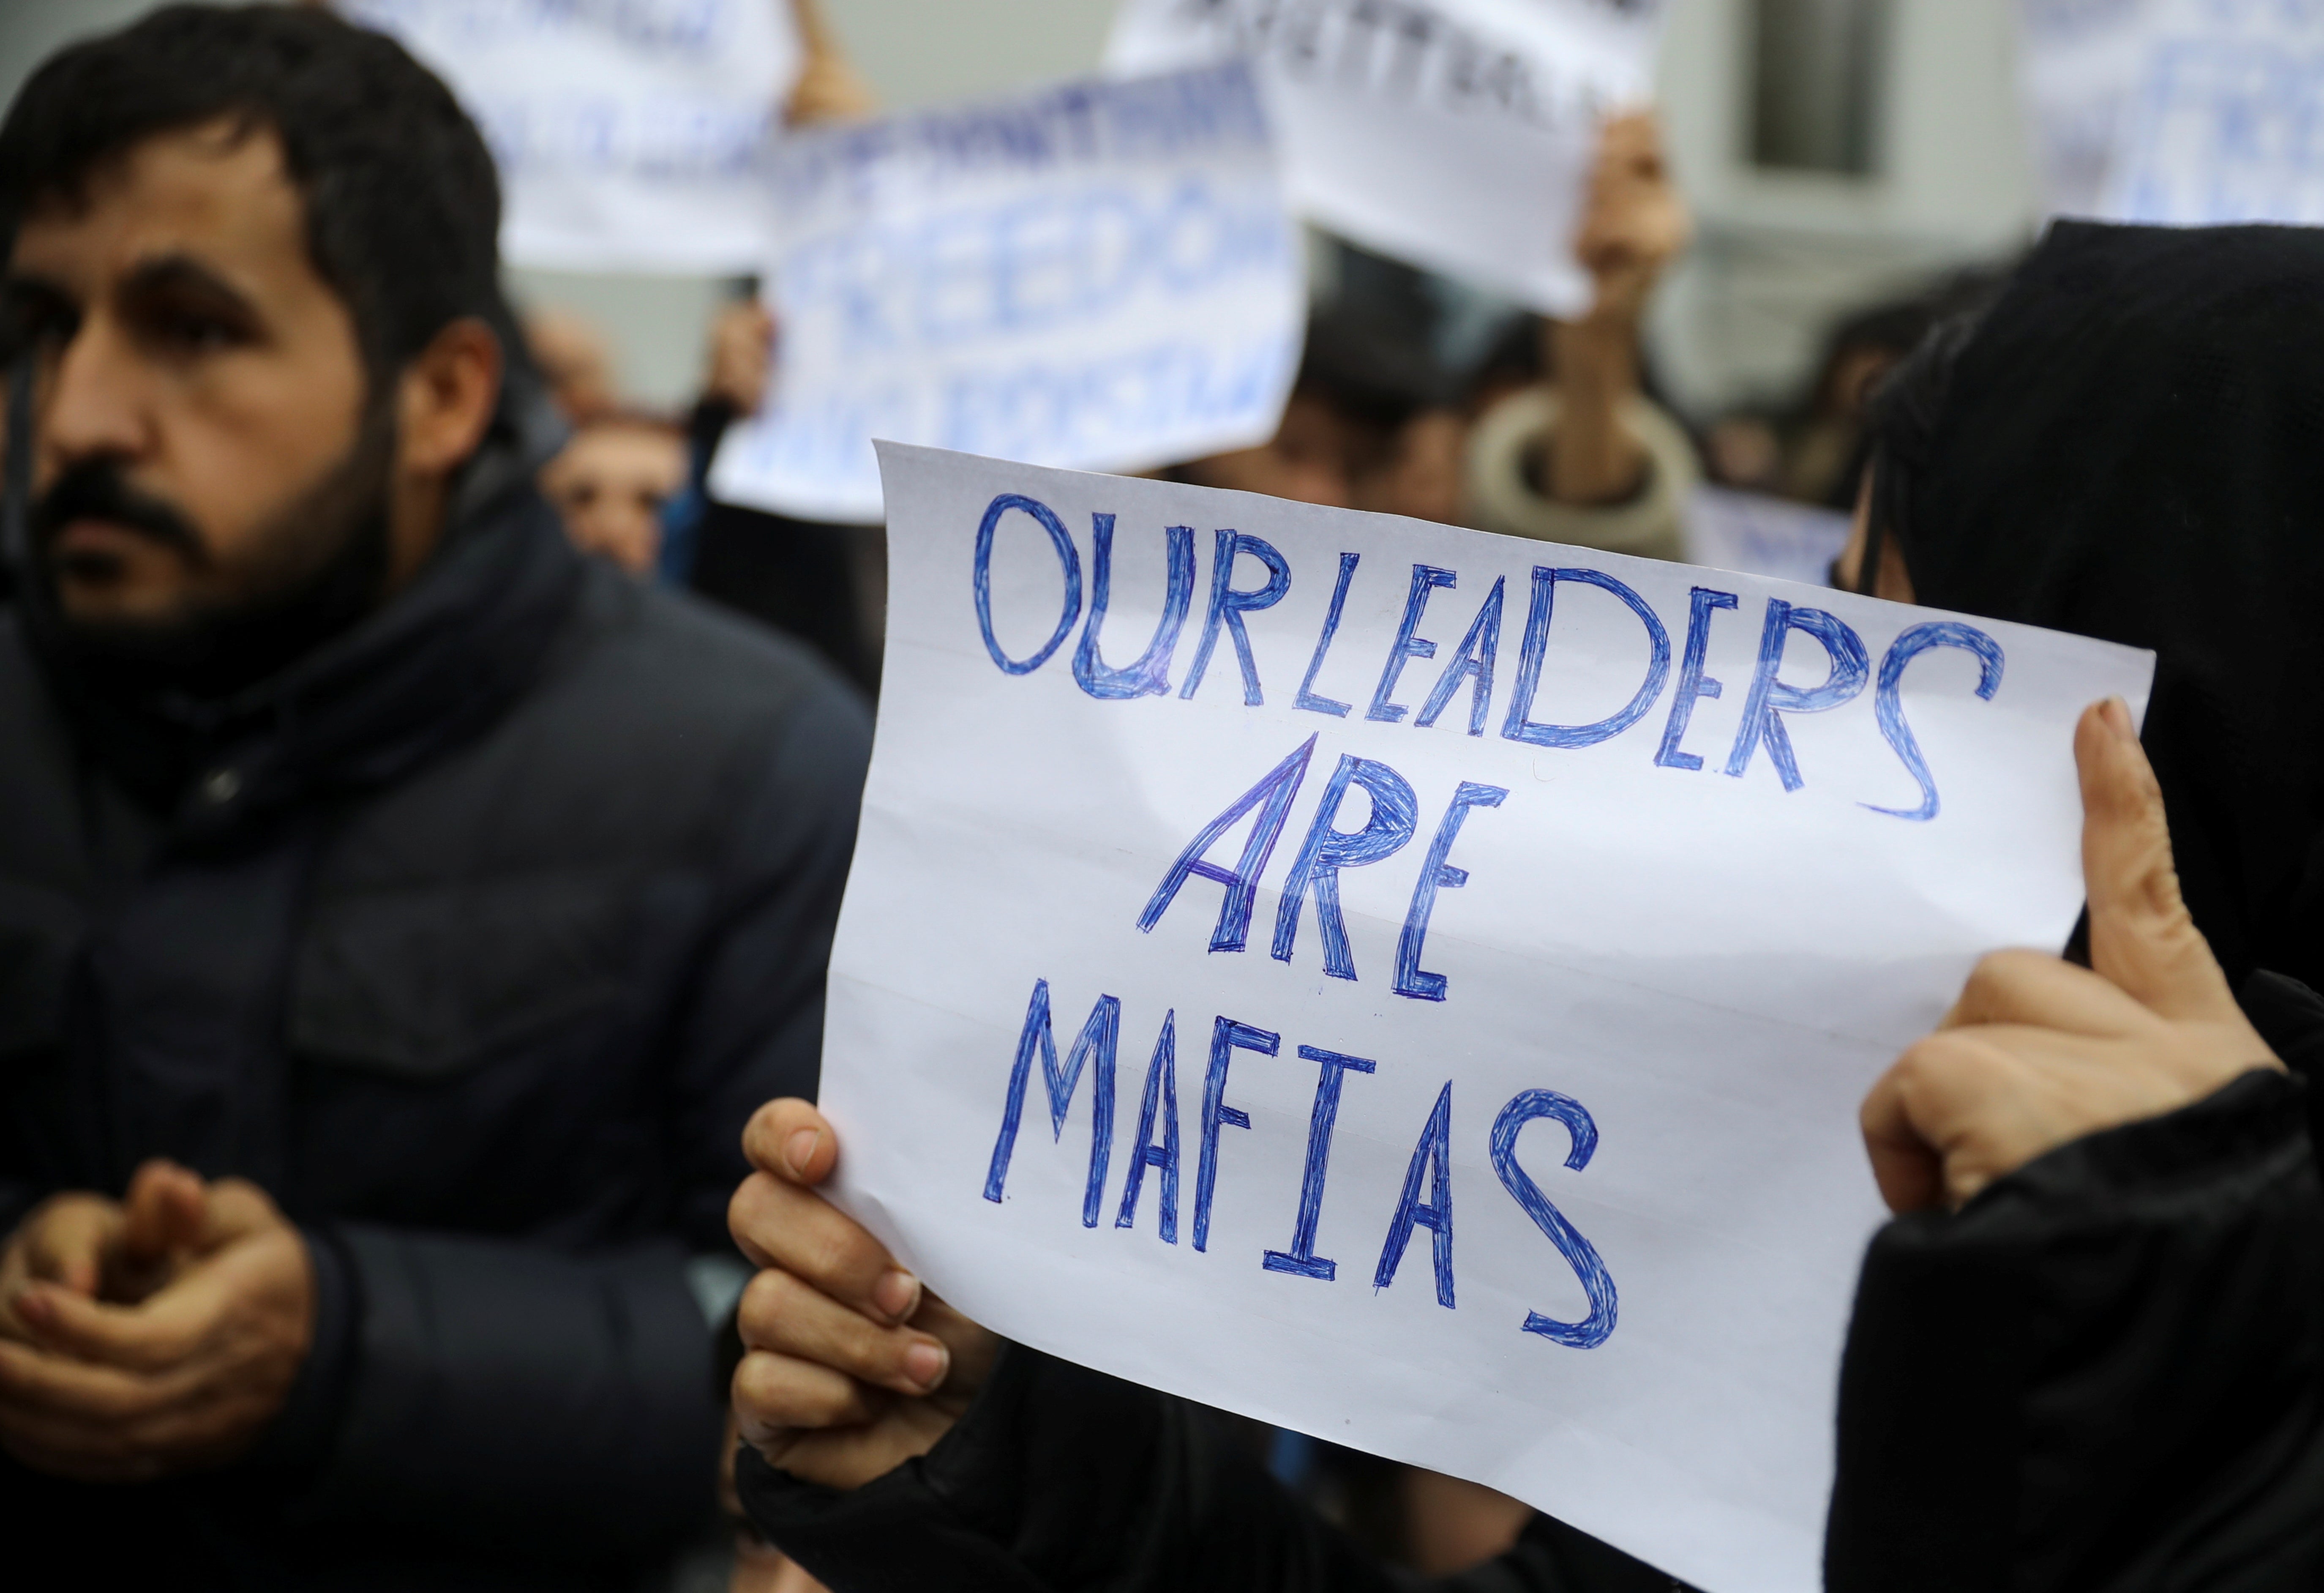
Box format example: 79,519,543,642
5,126,393,635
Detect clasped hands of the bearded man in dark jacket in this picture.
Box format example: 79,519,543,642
0,1161,314,1481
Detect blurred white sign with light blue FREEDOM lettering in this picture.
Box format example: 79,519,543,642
711,63,1306,521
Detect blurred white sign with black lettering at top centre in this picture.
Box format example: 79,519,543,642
1106,0,1662,316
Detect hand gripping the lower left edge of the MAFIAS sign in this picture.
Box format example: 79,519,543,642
728,1100,1002,1488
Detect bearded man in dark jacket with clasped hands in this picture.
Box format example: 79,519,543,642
0,7,867,1588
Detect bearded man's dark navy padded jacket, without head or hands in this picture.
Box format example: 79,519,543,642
0,395,869,1588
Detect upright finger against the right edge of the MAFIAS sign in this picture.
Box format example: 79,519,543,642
2073,698,2240,1021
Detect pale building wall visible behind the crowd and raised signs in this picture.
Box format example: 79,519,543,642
0,0,2034,412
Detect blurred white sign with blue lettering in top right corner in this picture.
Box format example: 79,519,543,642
2106,0,2324,226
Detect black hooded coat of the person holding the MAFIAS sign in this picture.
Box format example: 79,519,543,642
739,226,2324,1593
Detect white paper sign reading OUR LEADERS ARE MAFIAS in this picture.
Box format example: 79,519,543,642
823,444,2152,1593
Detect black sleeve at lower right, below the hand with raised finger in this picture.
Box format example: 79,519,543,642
1825,1068,2324,1593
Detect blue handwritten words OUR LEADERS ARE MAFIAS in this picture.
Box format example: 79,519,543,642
971,481,2006,1347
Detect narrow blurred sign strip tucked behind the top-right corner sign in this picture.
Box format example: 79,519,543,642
2017,0,2155,216
